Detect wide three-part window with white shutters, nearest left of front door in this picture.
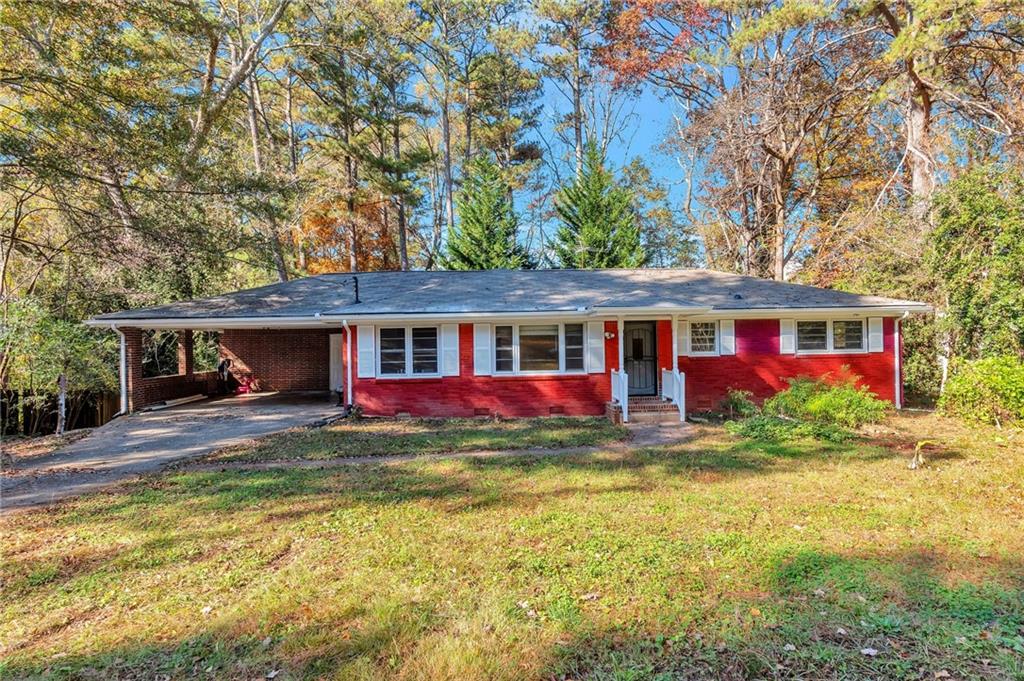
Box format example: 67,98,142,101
494,324,586,374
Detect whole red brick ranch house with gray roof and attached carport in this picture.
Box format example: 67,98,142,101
89,269,929,420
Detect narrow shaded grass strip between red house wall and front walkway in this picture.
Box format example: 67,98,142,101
207,417,627,462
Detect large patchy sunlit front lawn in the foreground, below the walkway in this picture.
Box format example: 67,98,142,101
0,416,1024,680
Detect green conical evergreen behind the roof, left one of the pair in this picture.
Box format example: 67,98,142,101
445,155,532,269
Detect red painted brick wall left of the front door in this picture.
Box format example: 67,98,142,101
352,323,618,417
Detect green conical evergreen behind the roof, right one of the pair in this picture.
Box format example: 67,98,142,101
554,142,647,269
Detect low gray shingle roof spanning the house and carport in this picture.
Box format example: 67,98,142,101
95,269,921,322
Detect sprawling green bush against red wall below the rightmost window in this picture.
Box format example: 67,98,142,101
764,371,889,428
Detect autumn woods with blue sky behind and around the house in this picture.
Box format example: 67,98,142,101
0,0,1024,432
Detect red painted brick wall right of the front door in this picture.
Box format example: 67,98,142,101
675,318,896,410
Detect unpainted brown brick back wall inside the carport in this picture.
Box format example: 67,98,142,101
220,329,329,390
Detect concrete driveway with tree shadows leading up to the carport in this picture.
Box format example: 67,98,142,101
0,393,341,511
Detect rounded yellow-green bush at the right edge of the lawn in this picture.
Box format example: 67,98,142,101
939,357,1024,425
